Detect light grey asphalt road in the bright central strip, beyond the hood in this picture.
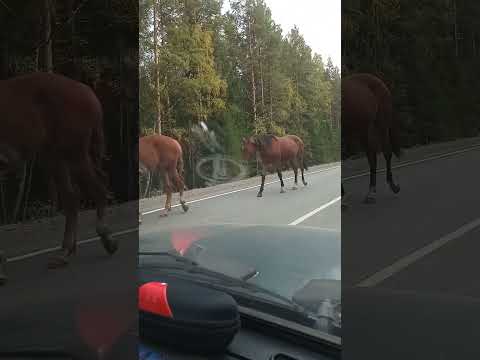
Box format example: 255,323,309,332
140,164,341,233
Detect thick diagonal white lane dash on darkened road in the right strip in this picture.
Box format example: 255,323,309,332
356,218,480,287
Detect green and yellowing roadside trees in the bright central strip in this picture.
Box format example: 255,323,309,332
140,0,340,186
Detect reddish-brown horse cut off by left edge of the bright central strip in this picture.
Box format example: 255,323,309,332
138,134,188,222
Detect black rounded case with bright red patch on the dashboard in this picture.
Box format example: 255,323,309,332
139,278,240,353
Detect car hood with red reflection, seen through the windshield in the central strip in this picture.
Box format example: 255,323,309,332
140,225,341,336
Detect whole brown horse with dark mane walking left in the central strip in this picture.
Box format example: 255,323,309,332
242,134,308,197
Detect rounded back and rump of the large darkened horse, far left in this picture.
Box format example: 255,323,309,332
0,72,103,155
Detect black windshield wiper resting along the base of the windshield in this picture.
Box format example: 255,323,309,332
139,251,312,319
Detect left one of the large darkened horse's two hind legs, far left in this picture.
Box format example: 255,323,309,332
48,161,79,269
